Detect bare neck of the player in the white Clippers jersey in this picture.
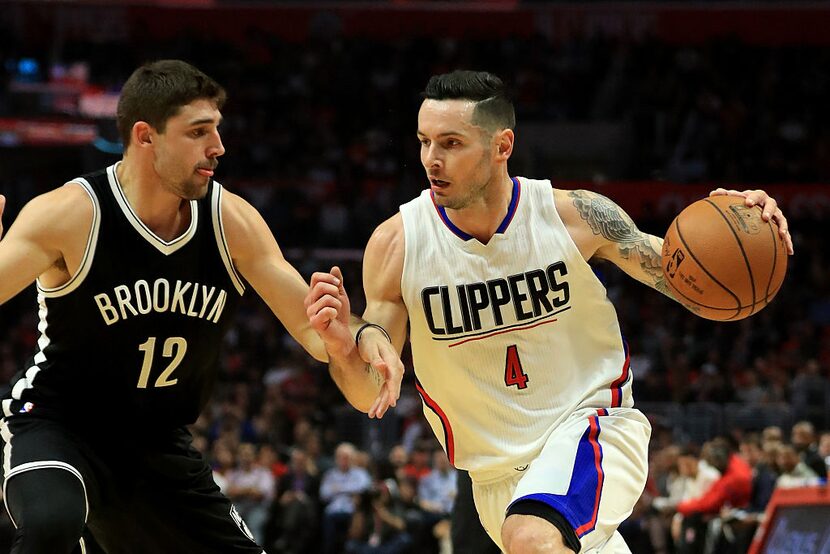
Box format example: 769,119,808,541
447,173,513,244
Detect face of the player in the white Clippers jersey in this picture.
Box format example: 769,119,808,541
418,99,495,210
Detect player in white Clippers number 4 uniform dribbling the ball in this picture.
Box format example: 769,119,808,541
306,71,792,554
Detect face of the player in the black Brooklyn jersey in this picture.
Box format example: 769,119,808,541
153,99,225,200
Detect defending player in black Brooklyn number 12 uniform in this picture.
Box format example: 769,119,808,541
0,60,403,554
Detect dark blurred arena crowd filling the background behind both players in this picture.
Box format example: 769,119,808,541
0,9,830,554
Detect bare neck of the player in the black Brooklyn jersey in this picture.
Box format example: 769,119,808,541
115,156,191,241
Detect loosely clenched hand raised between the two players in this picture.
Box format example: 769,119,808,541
305,266,354,356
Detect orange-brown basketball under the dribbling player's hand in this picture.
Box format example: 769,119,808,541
663,196,787,321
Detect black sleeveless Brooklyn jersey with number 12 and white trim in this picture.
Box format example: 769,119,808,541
2,165,245,430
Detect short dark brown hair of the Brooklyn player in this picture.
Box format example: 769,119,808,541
116,60,227,149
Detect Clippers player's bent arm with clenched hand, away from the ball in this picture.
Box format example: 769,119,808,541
306,214,408,417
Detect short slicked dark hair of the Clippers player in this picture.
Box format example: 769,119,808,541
422,69,516,131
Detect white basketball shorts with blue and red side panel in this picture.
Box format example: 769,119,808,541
470,408,651,554
